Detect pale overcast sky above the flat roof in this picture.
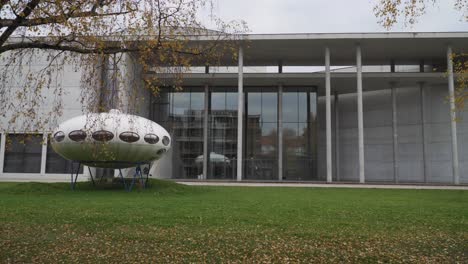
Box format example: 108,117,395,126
203,0,468,34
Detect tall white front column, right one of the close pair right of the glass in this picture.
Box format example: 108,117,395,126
356,45,365,183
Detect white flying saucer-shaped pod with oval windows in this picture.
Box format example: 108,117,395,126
51,110,171,169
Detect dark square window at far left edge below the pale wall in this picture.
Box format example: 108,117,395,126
3,134,42,173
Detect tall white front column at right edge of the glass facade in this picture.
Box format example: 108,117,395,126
325,47,332,182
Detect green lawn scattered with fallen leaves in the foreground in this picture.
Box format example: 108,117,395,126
0,181,468,263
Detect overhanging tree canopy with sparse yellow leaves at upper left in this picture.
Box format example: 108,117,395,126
0,0,246,131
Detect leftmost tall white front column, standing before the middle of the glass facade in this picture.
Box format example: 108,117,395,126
237,46,244,181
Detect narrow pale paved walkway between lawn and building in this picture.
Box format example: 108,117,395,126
177,181,468,191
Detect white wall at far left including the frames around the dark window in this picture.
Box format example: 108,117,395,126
0,50,88,181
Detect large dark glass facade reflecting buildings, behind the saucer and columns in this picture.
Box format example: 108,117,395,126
151,87,317,180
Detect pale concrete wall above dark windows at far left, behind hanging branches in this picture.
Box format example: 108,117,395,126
0,50,82,131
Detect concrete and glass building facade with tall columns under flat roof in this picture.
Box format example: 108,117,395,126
0,32,468,185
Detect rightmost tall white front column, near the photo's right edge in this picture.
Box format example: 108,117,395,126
447,46,460,184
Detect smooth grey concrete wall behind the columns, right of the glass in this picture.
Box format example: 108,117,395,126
318,85,462,183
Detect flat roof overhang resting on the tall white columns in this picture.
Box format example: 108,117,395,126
186,32,468,66
